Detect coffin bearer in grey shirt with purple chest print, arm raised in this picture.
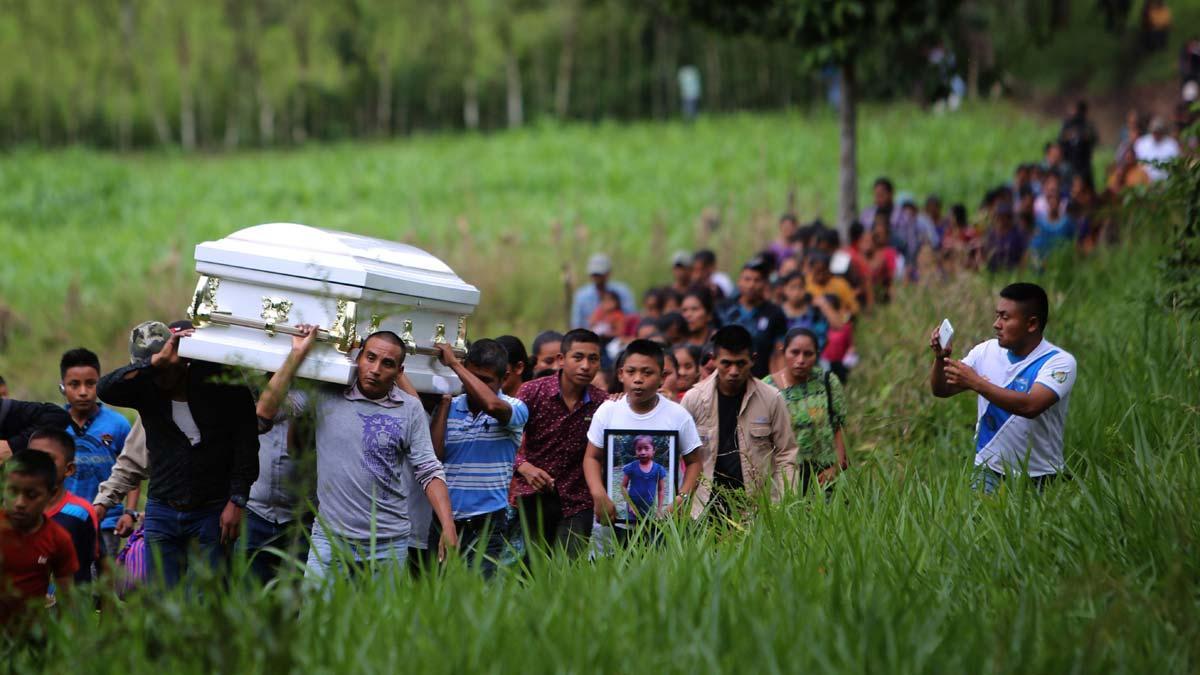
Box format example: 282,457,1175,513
258,325,458,579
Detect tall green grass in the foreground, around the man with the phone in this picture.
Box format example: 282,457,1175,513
10,229,1200,674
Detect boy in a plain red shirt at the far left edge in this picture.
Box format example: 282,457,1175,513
0,449,79,631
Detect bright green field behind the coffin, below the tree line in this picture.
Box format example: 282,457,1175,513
0,106,1056,398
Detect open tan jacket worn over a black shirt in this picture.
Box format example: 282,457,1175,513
682,372,799,518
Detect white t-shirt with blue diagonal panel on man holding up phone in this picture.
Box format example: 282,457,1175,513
962,340,1078,477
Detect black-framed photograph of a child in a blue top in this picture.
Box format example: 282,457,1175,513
605,429,679,527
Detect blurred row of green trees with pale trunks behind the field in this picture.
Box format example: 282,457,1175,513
0,0,835,150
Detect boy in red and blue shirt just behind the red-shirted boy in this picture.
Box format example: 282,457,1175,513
29,429,100,584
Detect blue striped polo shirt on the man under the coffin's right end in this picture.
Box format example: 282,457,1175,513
442,393,529,520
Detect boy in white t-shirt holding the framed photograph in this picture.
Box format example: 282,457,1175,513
583,340,701,525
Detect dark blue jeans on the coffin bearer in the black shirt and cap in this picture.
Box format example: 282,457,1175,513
145,500,224,587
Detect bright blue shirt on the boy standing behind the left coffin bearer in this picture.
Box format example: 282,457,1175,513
64,404,130,530
